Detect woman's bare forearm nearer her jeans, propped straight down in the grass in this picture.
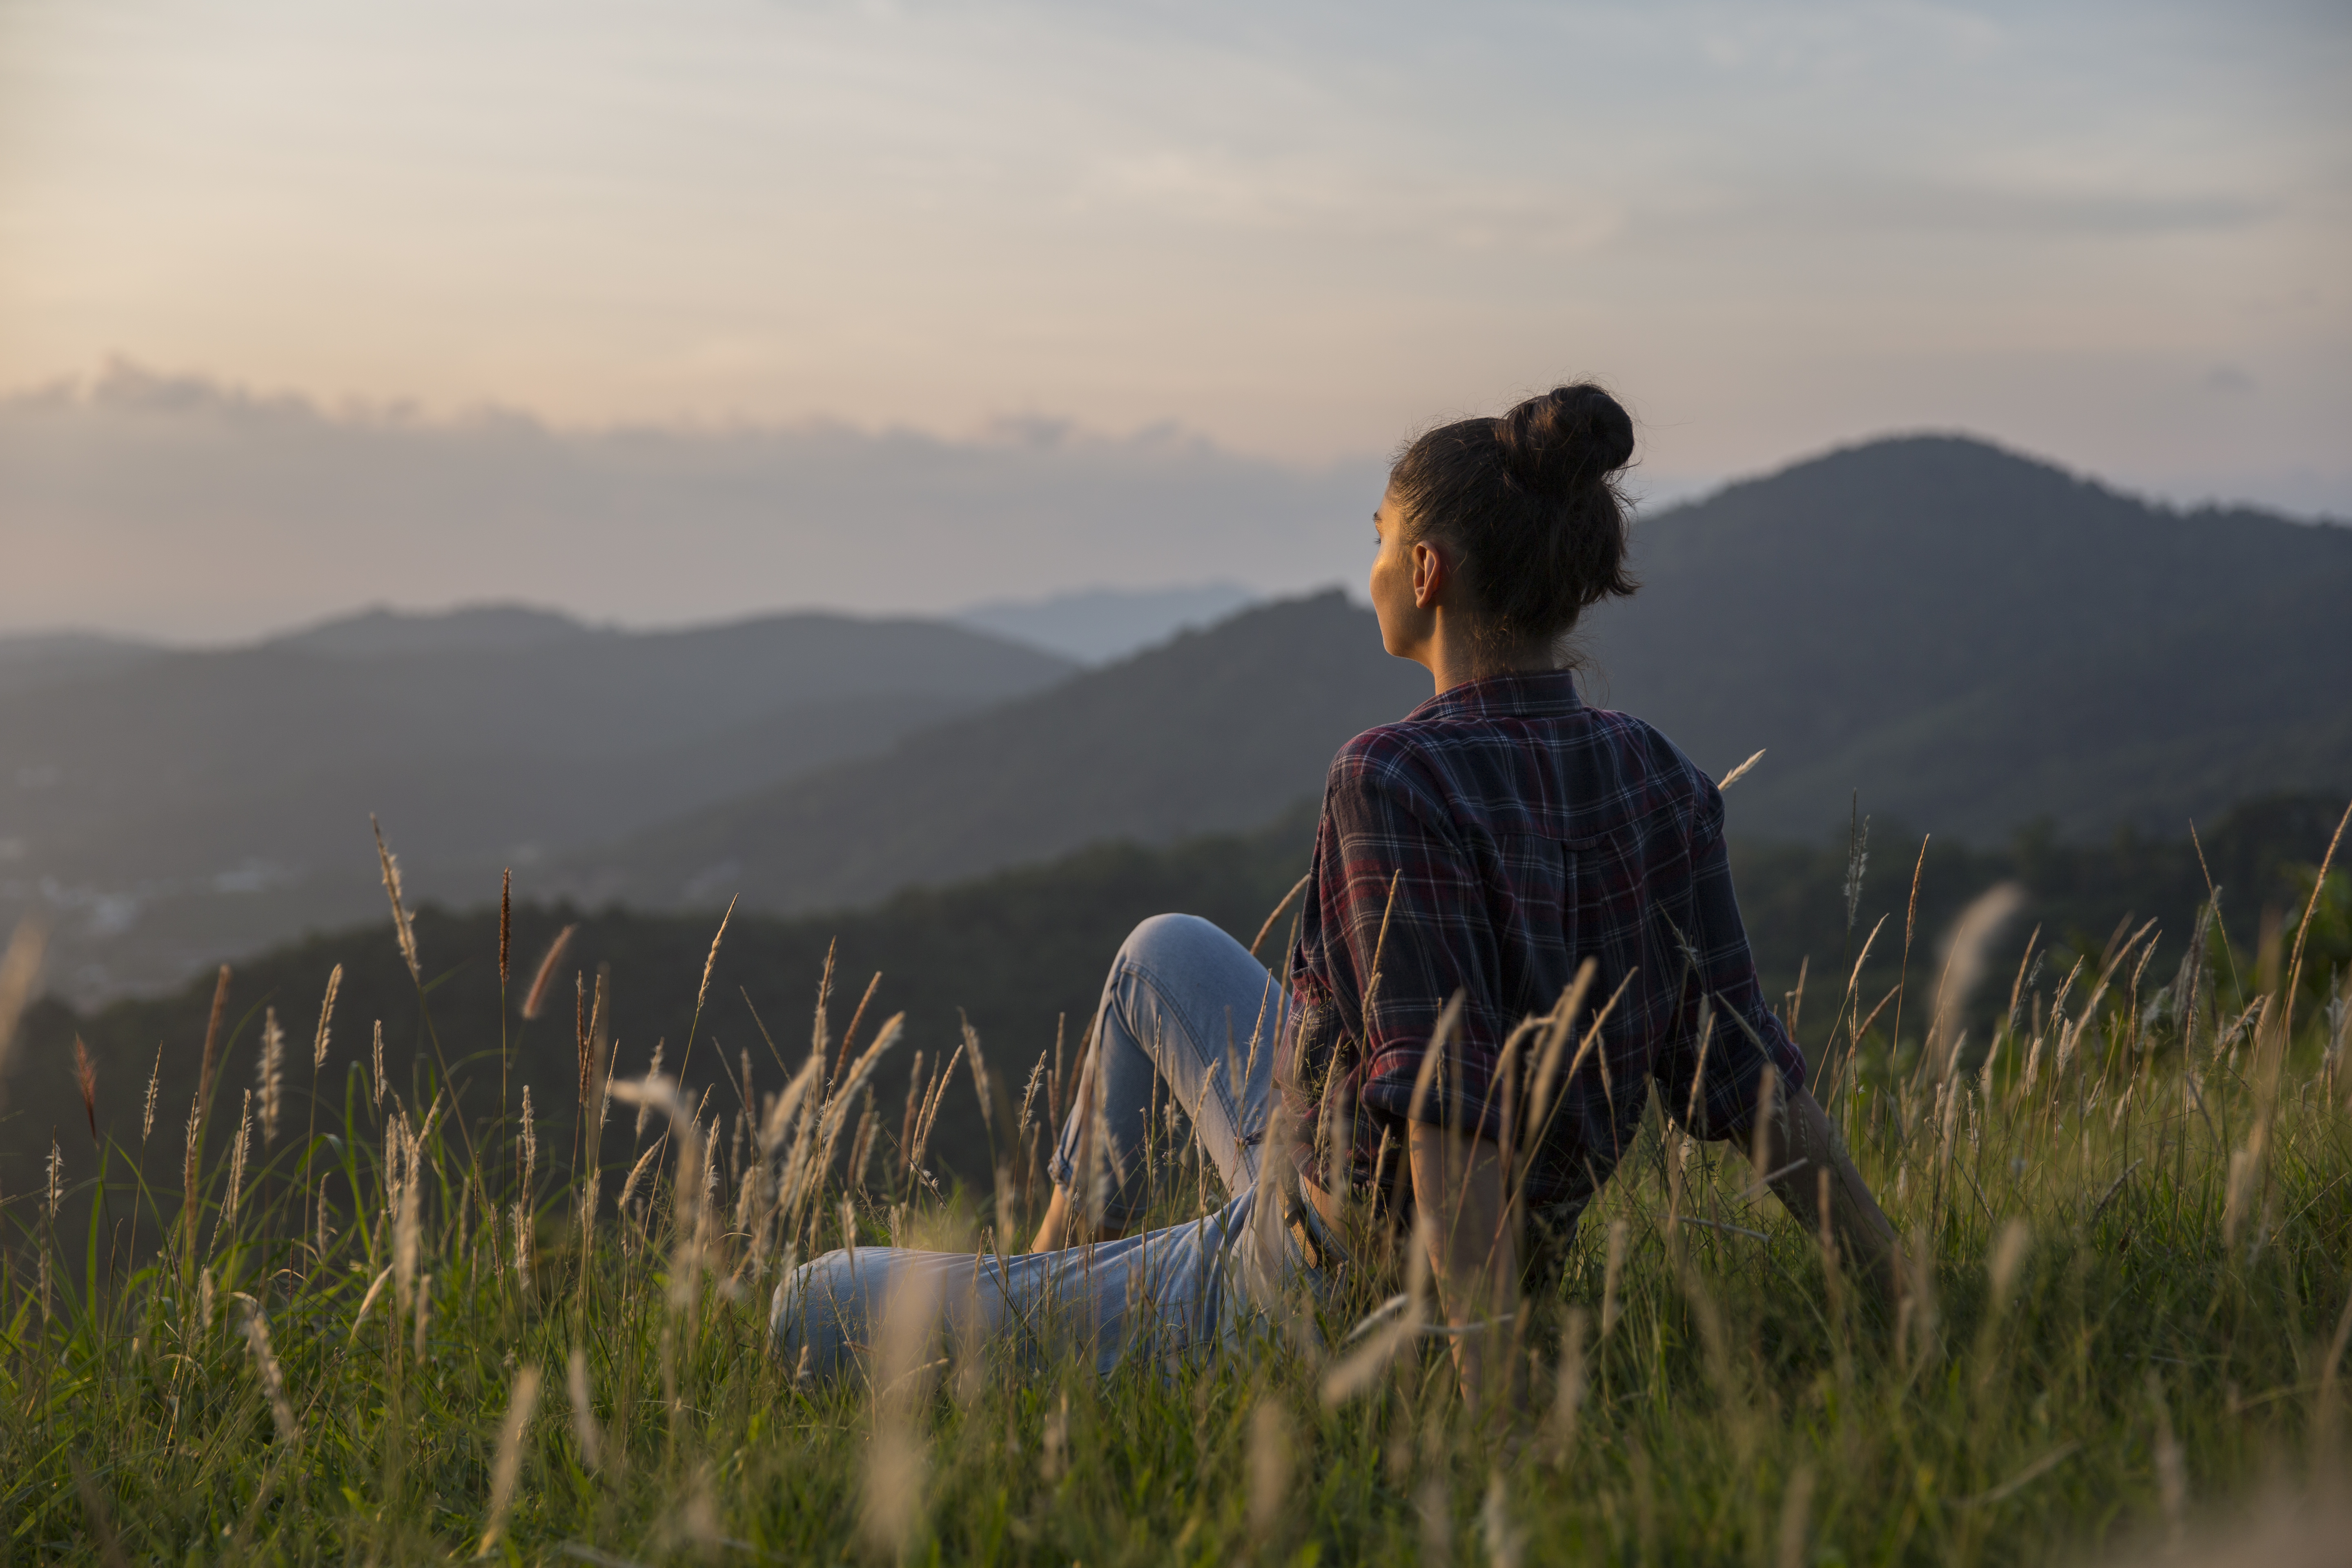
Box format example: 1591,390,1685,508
1406,1121,1519,1403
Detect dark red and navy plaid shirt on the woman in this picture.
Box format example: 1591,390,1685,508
1277,673,1804,1211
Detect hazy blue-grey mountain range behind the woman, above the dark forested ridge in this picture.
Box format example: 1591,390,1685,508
0,437,2352,997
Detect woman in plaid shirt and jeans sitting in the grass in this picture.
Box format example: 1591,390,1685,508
774,385,1893,1392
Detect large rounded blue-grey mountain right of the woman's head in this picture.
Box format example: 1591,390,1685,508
1592,437,2352,842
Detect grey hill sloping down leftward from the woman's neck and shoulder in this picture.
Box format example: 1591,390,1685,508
560,592,1430,910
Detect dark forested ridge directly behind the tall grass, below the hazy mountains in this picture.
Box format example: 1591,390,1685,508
0,785,2352,1192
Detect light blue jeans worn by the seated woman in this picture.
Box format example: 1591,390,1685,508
769,915,1312,1378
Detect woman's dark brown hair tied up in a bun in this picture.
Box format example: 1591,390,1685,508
1388,381,1635,670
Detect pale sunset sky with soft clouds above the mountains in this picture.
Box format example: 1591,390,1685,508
0,0,2352,637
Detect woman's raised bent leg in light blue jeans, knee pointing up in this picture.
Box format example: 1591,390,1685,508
1051,915,1284,1229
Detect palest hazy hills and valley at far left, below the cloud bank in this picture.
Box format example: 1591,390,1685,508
0,606,1073,994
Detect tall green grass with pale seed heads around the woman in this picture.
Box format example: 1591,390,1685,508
0,827,2352,1563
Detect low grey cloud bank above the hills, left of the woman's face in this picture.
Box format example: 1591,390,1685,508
0,364,1381,639
